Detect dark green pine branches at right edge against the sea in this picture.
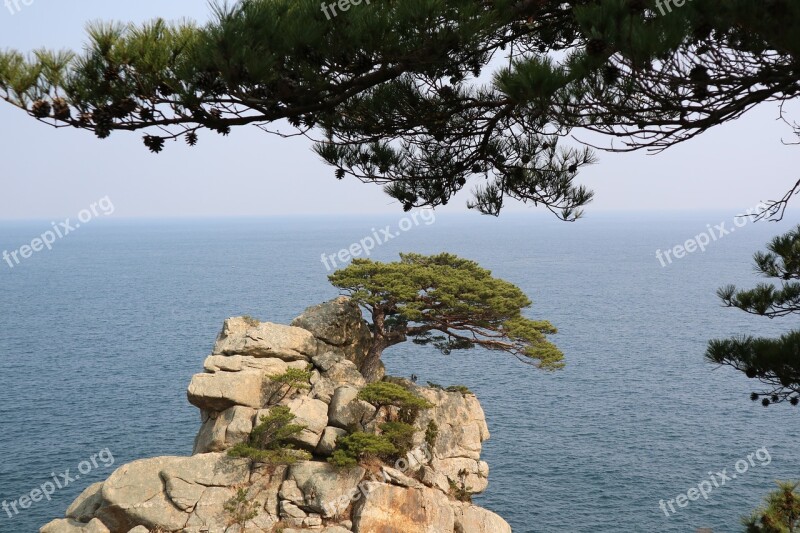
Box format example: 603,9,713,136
706,226,800,406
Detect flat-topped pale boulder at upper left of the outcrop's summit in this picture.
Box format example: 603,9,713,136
213,317,320,361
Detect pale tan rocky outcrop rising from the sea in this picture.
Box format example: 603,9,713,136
40,297,511,533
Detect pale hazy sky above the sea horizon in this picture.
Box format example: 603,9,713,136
0,0,798,219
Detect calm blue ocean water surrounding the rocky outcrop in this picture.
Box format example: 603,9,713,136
0,213,800,533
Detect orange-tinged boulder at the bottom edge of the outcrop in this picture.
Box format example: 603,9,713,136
353,483,455,533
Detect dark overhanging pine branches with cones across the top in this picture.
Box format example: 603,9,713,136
0,0,800,214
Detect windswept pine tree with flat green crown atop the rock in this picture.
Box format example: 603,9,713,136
329,253,563,381
